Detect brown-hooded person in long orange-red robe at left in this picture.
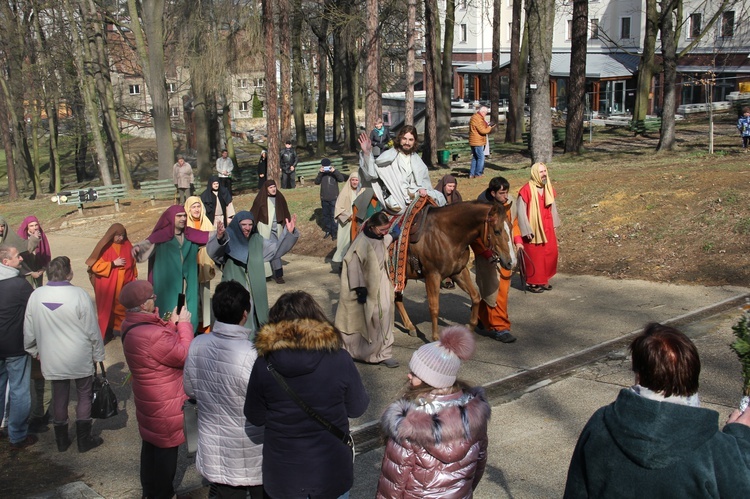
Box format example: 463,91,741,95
86,224,138,338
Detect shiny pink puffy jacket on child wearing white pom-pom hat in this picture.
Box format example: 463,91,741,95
377,388,491,499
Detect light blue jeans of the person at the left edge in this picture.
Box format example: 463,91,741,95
0,355,31,443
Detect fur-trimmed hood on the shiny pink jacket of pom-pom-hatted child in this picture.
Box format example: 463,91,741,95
380,387,492,459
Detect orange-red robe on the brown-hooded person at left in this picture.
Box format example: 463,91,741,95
91,240,138,338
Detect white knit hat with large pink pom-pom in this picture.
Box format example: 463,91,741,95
409,326,475,388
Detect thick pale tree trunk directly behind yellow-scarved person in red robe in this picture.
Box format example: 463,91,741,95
527,0,555,163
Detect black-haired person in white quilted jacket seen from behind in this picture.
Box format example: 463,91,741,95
184,281,265,499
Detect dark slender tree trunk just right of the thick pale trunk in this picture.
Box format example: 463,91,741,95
565,0,589,153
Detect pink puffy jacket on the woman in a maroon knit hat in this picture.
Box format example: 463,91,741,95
122,312,193,448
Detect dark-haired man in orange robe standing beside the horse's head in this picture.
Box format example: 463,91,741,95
471,177,523,343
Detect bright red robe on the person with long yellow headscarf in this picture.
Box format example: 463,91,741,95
518,182,557,286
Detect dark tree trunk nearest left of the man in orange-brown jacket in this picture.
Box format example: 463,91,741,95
435,0,456,146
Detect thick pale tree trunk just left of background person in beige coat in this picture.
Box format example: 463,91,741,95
133,0,175,179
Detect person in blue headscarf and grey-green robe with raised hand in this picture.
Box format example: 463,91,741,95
206,211,299,330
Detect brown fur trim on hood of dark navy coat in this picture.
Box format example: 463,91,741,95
255,319,343,356
